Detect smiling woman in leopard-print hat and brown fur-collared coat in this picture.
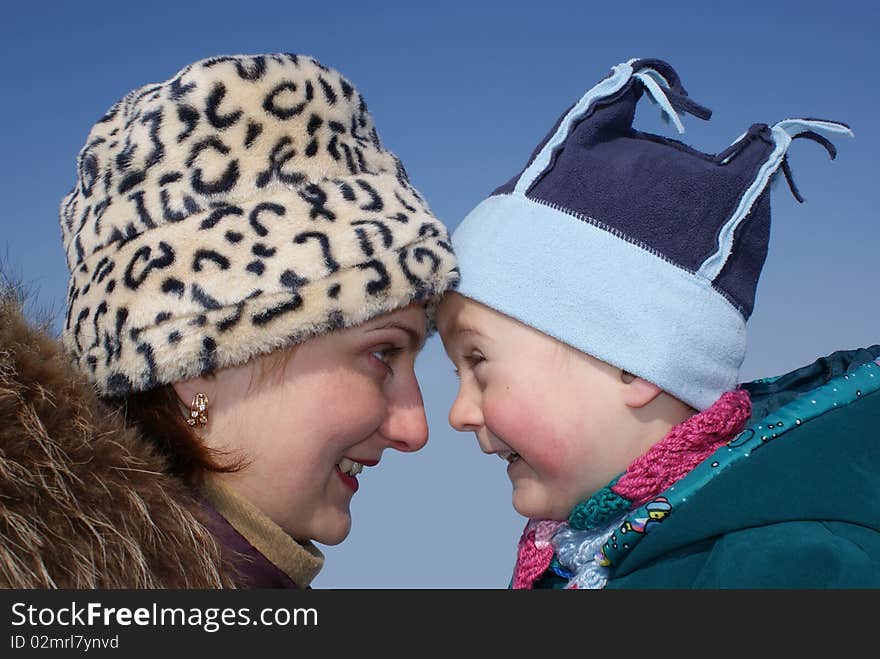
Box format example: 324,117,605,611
0,54,458,588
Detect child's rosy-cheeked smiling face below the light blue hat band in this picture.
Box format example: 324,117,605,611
437,293,644,519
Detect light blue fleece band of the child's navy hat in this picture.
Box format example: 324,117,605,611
452,193,746,410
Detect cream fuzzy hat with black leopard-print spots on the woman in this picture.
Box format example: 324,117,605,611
60,54,458,396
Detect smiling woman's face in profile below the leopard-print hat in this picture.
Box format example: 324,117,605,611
185,305,428,545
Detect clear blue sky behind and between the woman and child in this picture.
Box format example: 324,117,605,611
0,0,880,588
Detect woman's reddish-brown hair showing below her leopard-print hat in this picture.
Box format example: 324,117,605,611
111,384,244,482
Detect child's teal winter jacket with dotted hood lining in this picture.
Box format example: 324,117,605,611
536,345,880,589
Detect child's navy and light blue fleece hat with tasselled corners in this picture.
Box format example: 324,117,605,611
452,59,852,410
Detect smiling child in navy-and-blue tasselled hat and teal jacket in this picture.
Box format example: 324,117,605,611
438,60,880,588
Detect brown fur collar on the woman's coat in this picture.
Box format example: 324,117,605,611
0,291,241,588
